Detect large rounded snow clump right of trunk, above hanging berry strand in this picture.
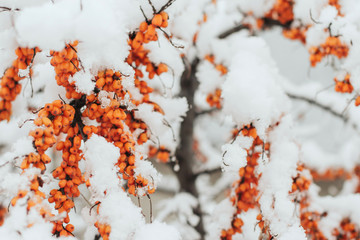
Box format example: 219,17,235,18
222,39,289,139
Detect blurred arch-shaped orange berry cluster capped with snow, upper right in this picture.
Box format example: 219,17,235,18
309,36,349,67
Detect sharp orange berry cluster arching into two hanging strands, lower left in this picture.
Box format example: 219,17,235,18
28,100,79,236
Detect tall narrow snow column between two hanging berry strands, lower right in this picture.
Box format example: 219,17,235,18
259,116,305,239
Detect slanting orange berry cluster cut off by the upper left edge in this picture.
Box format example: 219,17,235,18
0,47,40,121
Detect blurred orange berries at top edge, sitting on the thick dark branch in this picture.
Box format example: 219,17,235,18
265,0,294,25
